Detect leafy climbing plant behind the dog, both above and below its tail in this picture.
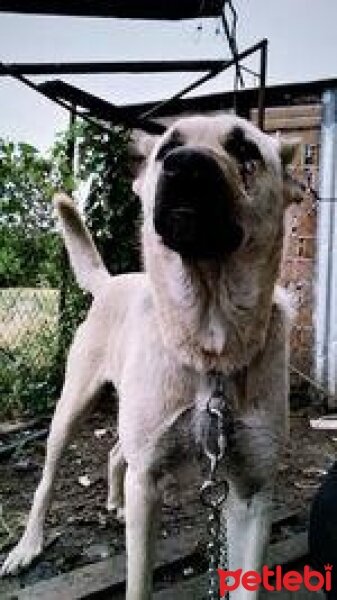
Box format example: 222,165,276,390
55,122,139,348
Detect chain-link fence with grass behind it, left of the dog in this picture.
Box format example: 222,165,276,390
0,236,67,414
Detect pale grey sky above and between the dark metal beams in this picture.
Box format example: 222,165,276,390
0,0,337,151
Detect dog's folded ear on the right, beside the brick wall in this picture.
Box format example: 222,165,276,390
278,136,305,207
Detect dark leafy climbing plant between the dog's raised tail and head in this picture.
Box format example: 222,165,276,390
72,123,140,273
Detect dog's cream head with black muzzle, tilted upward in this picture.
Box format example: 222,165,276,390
134,116,298,261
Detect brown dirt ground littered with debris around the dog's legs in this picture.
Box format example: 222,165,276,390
0,398,337,598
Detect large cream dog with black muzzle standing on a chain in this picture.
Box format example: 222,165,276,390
2,116,298,600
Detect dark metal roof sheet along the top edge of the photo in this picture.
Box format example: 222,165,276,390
0,0,224,20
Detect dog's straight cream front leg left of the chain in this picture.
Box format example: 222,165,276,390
125,465,159,600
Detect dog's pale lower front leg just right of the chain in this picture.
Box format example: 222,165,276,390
223,488,272,600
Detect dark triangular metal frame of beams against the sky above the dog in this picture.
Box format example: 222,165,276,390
0,39,268,133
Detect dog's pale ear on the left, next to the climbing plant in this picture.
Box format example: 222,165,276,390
129,129,159,196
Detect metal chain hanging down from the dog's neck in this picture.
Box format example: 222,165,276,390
200,373,232,600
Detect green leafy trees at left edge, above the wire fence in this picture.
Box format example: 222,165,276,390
0,139,60,287
